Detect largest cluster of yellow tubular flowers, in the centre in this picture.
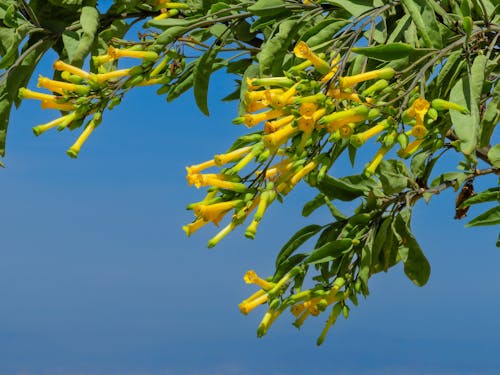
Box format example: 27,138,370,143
183,42,468,247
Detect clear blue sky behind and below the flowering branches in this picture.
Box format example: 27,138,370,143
0,48,500,375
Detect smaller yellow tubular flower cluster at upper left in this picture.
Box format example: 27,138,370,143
19,44,184,158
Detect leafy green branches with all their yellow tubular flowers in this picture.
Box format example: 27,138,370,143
0,0,500,344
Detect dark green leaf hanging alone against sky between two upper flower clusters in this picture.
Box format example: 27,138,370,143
193,47,219,116
